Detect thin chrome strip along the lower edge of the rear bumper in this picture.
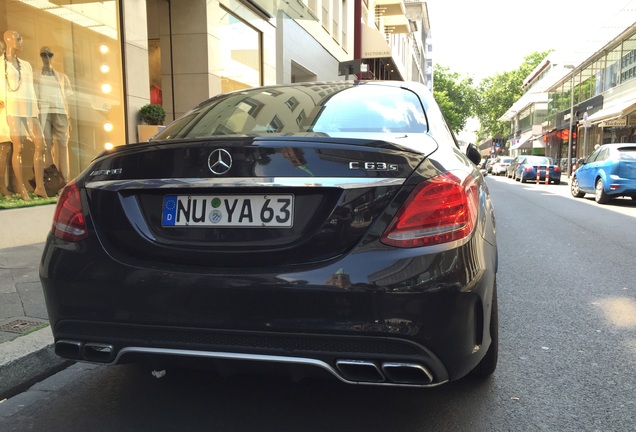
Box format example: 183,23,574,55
110,347,448,388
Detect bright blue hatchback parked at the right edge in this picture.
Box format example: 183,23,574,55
570,143,636,204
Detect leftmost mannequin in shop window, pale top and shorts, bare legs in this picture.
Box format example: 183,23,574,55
0,30,47,201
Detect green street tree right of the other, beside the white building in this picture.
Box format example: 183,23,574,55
475,51,550,141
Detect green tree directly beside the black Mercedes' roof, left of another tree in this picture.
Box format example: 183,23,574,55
433,66,477,134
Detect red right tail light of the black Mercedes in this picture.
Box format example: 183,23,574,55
380,173,479,248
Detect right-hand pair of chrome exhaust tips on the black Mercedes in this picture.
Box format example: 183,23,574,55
336,360,433,385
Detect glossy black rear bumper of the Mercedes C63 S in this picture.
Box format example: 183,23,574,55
41,231,496,386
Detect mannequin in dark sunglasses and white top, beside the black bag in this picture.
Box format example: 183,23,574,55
35,46,73,179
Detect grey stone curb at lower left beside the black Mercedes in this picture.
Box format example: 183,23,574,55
0,327,73,403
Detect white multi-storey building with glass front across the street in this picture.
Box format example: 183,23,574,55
500,2,636,173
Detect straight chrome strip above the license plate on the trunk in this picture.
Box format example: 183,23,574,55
86,177,406,191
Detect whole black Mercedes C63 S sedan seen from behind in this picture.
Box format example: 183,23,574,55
40,81,498,387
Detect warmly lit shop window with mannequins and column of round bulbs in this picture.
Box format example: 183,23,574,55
0,0,125,202
